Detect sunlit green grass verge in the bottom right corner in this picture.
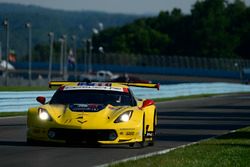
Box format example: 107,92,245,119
111,127,250,167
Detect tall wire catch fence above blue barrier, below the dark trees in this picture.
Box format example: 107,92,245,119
92,54,250,71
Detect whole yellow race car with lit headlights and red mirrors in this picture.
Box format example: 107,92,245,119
27,81,159,147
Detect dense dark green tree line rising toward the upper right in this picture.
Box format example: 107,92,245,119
93,0,250,59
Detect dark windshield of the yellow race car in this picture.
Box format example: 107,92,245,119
50,90,135,106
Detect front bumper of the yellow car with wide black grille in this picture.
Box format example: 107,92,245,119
27,127,142,144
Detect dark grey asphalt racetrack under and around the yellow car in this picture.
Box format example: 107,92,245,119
0,94,250,167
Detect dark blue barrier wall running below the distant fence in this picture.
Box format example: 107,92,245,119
12,62,240,79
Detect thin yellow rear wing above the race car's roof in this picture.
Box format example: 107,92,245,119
49,81,160,90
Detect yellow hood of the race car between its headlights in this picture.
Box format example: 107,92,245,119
45,105,134,129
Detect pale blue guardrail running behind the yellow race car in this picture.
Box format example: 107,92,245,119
0,83,250,112
